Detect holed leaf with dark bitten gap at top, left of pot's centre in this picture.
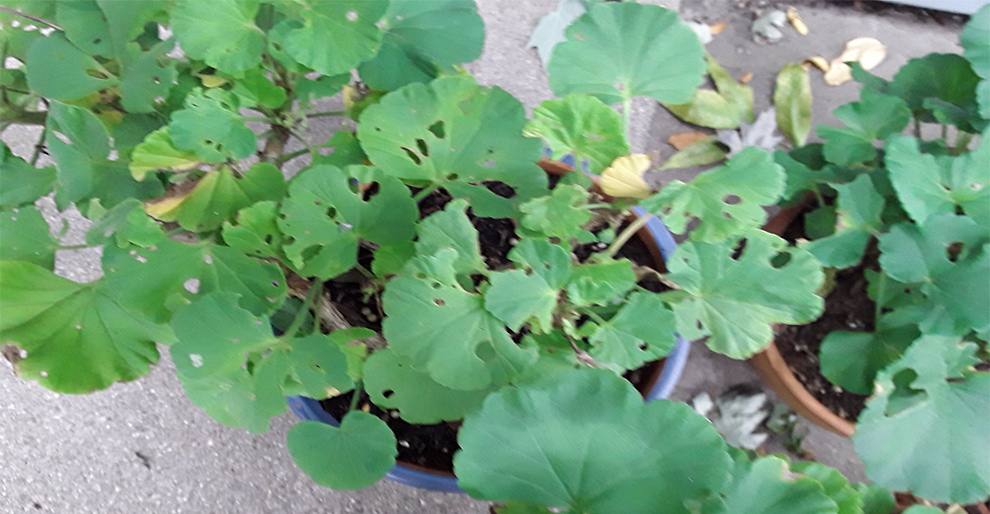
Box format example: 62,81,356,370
278,166,417,280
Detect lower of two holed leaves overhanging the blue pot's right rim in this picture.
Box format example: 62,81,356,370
667,231,824,359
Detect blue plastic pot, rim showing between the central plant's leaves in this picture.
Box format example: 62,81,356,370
288,158,691,493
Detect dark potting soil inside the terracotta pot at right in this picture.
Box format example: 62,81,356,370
774,206,880,422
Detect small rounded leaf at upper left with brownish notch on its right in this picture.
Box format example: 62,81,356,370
25,32,119,100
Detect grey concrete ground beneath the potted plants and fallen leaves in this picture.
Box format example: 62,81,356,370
0,0,976,514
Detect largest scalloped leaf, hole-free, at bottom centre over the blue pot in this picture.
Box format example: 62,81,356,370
454,368,730,514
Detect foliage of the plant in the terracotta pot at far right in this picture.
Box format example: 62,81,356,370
776,7,990,502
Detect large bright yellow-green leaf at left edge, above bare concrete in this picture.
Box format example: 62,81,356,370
0,262,174,394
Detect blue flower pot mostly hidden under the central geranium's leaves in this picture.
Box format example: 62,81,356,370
287,159,691,493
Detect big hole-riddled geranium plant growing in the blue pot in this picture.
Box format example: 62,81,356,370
0,0,900,513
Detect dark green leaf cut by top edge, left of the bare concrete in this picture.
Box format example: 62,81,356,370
358,0,485,91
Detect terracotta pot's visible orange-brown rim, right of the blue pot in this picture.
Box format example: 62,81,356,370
749,202,856,437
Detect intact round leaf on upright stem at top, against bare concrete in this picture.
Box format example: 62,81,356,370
547,3,707,105
